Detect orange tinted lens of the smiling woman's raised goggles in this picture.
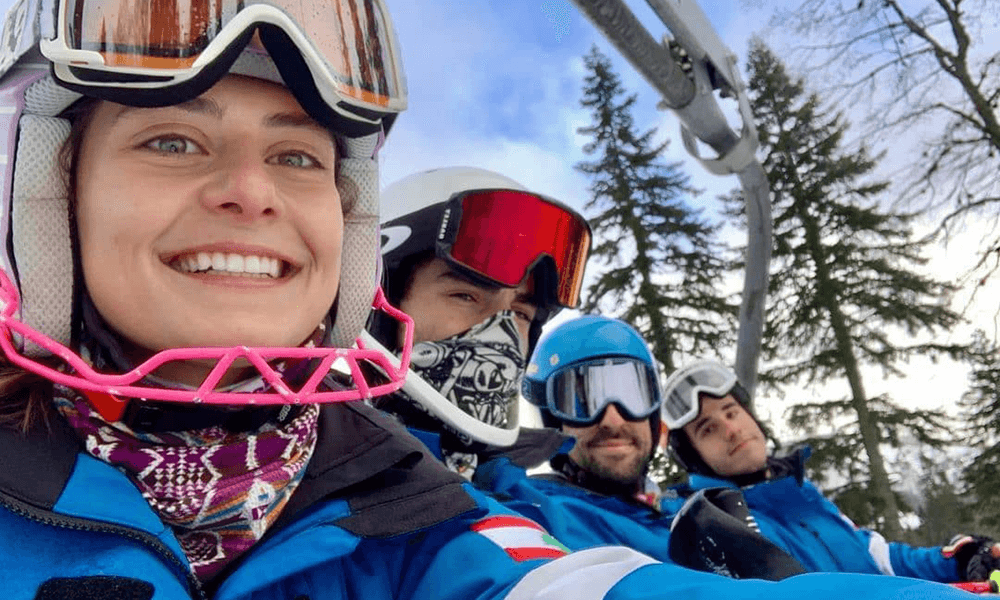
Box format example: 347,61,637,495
66,0,403,106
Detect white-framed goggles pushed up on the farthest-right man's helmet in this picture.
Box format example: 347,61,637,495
662,361,739,429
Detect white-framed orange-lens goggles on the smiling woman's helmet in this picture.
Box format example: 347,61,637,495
40,0,406,133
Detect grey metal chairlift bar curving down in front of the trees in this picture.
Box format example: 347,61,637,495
573,0,771,395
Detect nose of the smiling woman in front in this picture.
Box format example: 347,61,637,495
202,151,279,223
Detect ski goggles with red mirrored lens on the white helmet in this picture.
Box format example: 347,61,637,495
437,190,590,308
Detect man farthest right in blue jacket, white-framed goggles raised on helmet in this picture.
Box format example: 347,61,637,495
663,360,1000,582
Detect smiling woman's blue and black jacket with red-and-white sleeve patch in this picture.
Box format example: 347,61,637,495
0,403,653,600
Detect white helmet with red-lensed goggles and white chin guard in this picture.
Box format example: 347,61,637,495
369,167,591,446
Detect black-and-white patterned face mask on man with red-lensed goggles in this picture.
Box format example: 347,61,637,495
410,310,526,428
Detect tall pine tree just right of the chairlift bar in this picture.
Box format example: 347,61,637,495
736,40,962,539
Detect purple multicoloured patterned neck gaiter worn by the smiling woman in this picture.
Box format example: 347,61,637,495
56,386,319,582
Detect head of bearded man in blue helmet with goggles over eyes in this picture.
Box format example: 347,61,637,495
522,315,660,506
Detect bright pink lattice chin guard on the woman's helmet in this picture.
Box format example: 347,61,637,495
0,270,413,420
